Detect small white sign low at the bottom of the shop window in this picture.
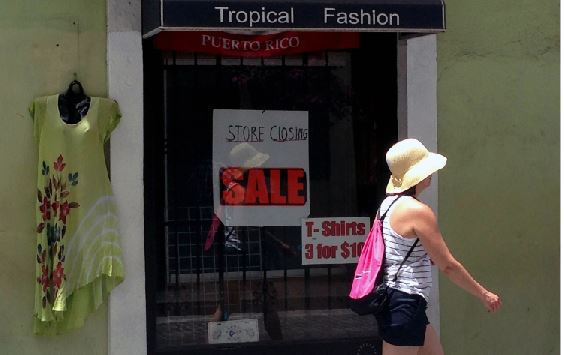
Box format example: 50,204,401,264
208,319,259,344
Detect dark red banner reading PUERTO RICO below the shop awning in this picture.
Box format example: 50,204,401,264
154,31,359,57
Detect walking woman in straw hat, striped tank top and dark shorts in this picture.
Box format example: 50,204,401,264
377,139,501,355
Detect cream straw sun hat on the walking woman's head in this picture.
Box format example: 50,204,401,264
386,138,446,194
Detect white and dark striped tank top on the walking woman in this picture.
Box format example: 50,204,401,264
380,196,433,301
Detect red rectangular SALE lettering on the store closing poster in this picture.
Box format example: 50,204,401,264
219,167,307,206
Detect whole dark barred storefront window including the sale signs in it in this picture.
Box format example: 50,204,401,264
145,34,397,354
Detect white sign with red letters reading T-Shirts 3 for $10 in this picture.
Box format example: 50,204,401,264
302,217,370,265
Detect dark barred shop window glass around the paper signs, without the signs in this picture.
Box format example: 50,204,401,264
144,33,398,355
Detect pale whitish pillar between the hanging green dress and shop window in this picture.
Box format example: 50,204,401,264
107,0,147,355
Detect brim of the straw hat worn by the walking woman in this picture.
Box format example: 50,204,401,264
386,153,447,194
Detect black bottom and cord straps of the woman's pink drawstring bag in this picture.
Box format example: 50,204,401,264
349,199,419,316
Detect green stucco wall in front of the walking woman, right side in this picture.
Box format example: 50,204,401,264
438,0,560,355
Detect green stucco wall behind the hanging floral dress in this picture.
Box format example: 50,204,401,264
0,0,108,355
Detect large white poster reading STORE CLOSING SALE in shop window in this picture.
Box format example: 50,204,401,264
213,109,310,226
